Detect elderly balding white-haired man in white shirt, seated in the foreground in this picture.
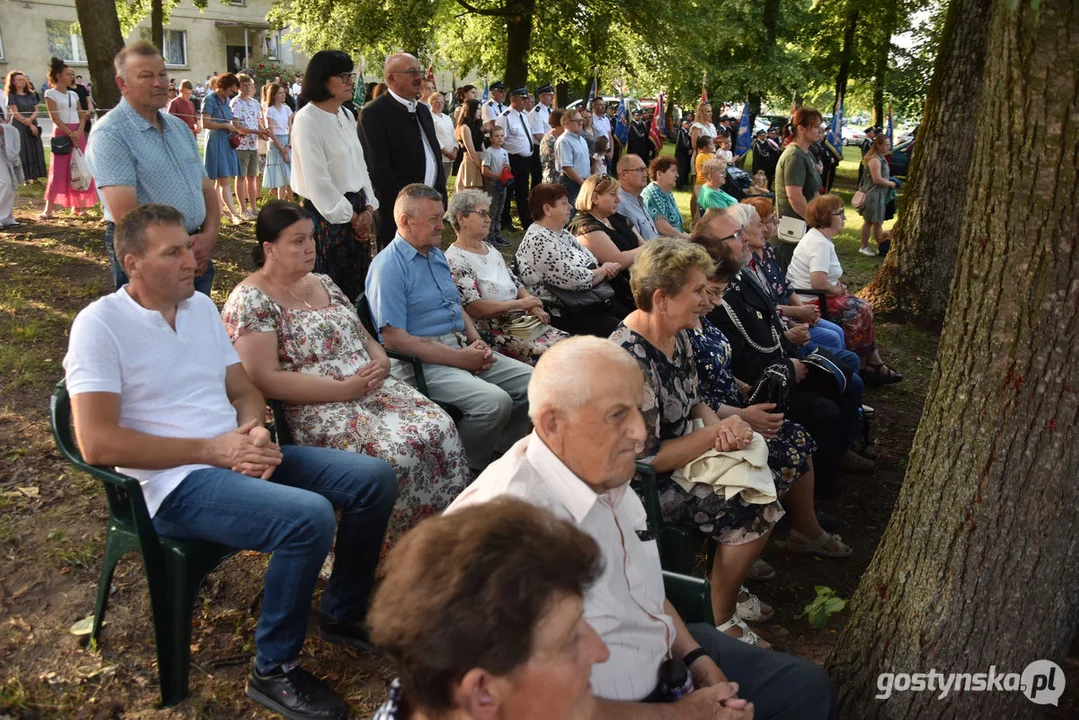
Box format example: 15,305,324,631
447,336,836,720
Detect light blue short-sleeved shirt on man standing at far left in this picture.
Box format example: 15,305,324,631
86,99,206,232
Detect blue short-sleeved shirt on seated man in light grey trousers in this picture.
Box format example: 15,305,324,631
365,235,465,337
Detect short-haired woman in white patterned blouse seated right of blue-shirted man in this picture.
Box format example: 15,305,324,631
446,190,570,365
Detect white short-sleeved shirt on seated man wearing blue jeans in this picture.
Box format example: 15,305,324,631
64,286,240,517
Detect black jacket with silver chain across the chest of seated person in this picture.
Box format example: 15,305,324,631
708,272,796,385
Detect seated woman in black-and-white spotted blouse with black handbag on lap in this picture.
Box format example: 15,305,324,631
517,182,630,338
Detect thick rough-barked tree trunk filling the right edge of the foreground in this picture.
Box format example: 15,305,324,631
829,0,1079,720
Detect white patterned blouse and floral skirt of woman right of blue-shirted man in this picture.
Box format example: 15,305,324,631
446,243,570,365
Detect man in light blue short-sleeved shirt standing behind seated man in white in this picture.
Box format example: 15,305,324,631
86,41,221,295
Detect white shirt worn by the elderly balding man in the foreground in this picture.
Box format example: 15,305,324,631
446,432,674,701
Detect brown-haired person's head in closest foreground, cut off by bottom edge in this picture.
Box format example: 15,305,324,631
368,498,612,720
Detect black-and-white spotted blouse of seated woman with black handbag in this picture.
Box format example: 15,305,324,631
517,222,600,308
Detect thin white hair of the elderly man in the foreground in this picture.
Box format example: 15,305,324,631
529,335,640,422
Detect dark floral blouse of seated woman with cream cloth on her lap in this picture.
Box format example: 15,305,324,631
611,324,701,463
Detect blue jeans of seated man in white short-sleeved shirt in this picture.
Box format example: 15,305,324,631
153,445,397,671
